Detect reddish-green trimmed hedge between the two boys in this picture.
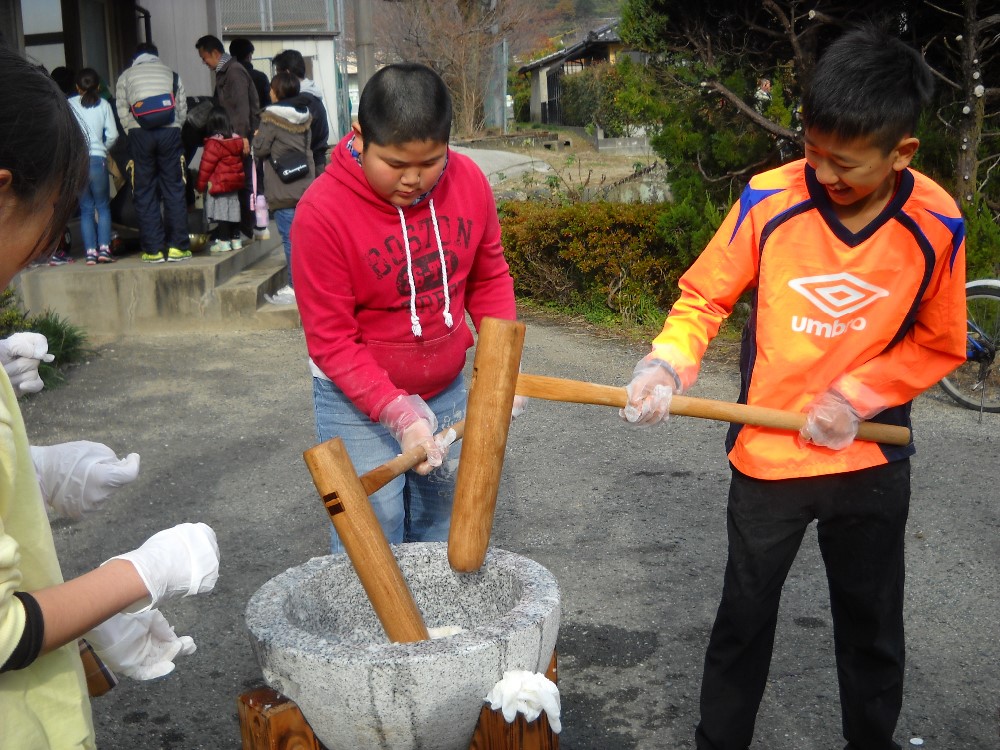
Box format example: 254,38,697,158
500,200,721,327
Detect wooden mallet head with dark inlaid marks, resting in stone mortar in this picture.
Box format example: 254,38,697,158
302,438,430,643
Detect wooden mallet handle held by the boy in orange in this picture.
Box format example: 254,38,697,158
517,373,910,445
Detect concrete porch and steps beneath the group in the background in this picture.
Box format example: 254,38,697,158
13,232,300,343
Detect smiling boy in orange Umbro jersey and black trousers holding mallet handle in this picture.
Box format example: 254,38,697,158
622,23,965,750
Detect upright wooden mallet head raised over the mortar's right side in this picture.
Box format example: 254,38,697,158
448,318,524,573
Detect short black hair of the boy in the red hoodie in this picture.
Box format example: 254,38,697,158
358,63,451,148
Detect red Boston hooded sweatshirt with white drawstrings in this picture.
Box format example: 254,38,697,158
292,136,516,420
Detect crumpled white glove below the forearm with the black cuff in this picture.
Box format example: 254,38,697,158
84,609,197,680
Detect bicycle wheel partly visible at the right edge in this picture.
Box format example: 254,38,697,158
941,284,1000,413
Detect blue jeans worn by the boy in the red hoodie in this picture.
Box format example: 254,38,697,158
313,375,468,553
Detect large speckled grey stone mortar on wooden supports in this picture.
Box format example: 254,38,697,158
246,542,560,750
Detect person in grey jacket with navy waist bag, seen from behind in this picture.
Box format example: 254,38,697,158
115,42,191,263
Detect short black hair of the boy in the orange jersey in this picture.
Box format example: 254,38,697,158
802,25,934,154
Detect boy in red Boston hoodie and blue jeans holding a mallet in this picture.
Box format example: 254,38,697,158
292,63,520,552
